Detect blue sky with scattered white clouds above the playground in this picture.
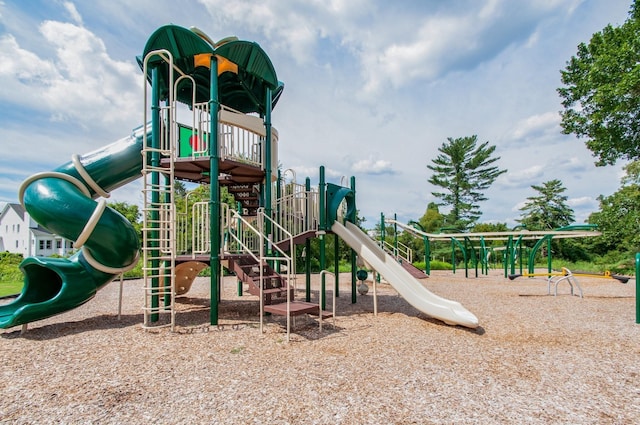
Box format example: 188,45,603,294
0,0,631,228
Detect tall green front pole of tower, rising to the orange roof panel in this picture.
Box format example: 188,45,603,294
209,55,221,325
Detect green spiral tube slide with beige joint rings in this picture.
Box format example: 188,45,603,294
0,127,143,328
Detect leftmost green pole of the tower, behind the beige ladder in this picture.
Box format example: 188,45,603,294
150,67,160,322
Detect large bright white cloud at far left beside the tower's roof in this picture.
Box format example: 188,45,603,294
0,21,142,127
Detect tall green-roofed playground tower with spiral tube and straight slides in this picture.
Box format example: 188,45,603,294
0,25,478,338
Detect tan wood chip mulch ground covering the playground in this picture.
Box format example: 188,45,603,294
0,270,640,424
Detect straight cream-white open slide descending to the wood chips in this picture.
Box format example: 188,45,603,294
331,221,478,329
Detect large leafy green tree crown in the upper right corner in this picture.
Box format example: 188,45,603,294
558,0,640,166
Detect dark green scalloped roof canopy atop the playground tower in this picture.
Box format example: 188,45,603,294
138,25,284,114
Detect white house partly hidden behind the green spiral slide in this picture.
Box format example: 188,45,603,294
0,203,73,258
